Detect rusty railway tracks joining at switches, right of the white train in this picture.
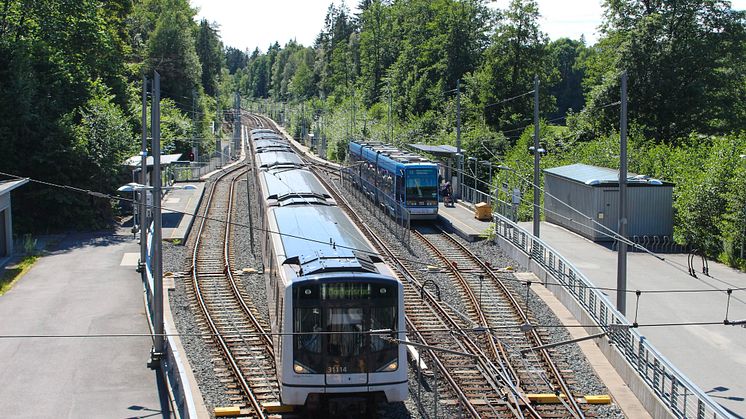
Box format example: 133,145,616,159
250,113,585,418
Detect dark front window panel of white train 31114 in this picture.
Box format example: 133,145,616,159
293,282,398,374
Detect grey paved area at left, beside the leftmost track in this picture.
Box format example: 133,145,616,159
0,229,167,418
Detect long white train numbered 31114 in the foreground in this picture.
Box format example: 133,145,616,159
255,139,408,407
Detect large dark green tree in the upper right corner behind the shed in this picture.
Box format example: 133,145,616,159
589,0,746,142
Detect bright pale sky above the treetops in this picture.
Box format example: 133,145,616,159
190,0,746,51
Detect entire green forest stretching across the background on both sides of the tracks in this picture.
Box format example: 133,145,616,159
0,0,746,268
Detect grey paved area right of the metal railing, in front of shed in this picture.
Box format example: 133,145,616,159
519,222,746,418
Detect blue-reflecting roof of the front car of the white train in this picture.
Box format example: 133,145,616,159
270,206,382,280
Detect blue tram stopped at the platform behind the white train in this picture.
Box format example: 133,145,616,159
349,141,439,220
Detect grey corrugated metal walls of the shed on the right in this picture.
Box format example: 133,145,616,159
544,172,673,241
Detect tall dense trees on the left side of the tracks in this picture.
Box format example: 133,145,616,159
0,0,231,234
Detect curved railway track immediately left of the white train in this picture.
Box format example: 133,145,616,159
192,161,279,417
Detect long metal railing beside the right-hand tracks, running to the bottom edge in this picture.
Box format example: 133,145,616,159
493,214,732,419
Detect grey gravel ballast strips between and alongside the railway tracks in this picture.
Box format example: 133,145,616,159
163,144,623,418
